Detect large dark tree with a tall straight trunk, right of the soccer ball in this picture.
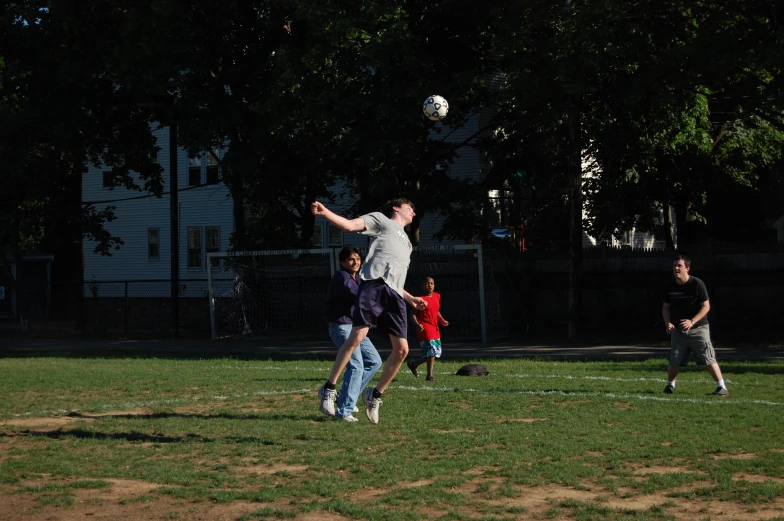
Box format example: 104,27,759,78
488,0,781,338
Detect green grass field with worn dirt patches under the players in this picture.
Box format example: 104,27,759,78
0,358,784,521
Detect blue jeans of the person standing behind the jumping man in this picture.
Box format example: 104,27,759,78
329,322,381,417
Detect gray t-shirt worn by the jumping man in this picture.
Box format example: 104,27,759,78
359,212,411,297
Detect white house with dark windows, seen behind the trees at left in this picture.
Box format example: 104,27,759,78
82,123,234,291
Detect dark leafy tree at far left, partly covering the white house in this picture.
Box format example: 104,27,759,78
0,1,161,319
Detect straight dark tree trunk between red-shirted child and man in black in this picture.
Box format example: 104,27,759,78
567,107,583,340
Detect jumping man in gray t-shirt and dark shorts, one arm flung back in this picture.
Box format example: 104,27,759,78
311,198,427,423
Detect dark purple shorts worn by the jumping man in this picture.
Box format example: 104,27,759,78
353,279,408,338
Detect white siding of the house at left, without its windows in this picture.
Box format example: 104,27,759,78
82,128,234,281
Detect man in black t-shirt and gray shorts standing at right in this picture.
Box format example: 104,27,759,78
662,255,729,396
